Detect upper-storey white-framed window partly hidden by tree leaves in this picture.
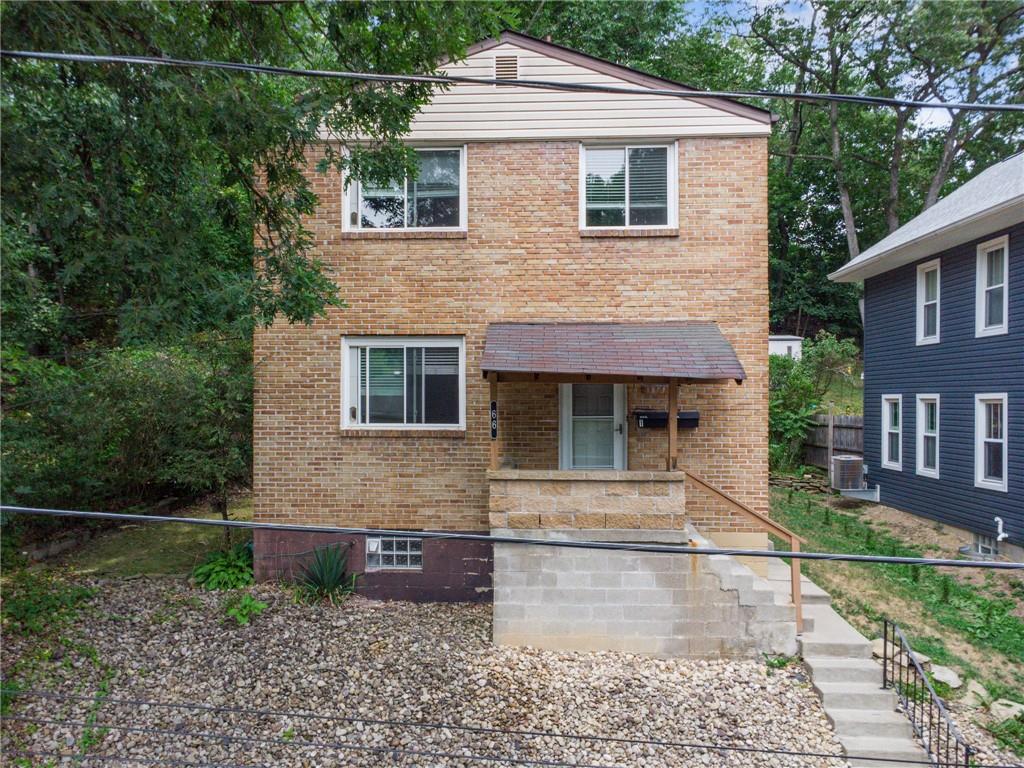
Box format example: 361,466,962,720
342,146,467,231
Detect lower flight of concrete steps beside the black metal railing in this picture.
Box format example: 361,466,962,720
768,560,928,768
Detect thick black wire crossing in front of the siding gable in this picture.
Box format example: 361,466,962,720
0,50,1024,112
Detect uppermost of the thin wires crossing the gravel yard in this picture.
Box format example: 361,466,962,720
2,688,999,768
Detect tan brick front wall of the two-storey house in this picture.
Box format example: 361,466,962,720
255,138,768,530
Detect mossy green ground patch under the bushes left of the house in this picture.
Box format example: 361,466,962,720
65,496,253,577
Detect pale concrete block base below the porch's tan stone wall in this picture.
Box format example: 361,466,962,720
492,527,797,658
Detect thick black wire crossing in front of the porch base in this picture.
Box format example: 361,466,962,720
0,505,1024,570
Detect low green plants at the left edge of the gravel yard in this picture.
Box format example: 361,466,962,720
3,569,95,635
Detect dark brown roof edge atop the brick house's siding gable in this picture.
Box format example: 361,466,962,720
466,30,778,125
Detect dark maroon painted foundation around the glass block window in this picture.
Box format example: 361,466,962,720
253,530,494,602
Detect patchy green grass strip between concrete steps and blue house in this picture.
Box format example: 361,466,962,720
772,492,1024,700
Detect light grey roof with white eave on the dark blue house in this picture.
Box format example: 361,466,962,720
828,153,1024,283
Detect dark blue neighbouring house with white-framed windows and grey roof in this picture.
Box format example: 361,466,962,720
829,154,1024,560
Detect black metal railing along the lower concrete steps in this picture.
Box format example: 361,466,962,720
882,618,977,768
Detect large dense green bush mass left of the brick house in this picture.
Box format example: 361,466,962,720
0,338,252,518
